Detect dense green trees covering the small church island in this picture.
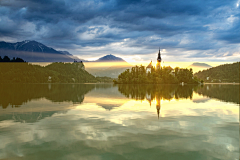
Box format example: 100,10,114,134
113,65,199,84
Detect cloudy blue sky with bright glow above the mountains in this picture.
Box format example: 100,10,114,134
0,0,240,62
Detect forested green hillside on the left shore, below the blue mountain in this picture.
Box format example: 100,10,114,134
0,62,98,83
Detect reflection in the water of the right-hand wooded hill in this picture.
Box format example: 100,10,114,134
195,84,239,104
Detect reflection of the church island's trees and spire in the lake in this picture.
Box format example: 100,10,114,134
118,85,198,118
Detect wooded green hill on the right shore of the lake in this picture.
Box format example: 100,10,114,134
194,62,240,83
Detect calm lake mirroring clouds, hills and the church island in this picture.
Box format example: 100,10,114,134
0,84,239,160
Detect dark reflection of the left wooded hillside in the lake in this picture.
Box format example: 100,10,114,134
0,84,95,108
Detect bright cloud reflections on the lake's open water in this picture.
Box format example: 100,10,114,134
0,91,239,159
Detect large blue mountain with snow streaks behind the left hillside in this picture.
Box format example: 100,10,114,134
0,40,80,62
